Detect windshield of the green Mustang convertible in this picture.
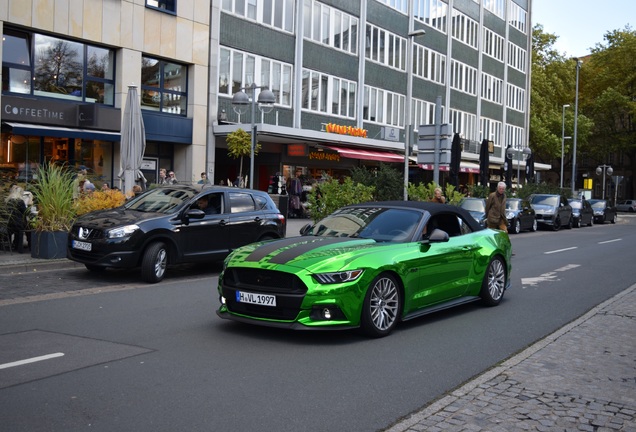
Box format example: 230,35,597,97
307,207,422,242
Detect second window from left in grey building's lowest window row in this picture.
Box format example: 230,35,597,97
302,69,356,118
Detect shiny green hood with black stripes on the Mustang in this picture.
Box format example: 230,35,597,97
229,236,386,268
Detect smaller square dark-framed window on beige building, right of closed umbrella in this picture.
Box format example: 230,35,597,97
141,56,188,116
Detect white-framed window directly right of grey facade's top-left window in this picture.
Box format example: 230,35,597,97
303,0,358,54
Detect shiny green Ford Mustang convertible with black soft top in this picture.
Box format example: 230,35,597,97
217,201,511,337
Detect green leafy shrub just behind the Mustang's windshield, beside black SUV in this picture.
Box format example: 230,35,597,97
307,177,375,222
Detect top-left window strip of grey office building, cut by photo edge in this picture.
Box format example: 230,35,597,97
221,0,295,33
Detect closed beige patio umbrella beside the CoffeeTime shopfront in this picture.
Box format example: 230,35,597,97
118,85,146,193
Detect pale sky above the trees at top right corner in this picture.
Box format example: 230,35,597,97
532,0,636,57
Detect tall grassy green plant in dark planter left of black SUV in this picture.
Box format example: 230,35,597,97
32,164,75,231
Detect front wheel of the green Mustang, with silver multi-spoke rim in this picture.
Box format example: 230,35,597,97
361,274,402,337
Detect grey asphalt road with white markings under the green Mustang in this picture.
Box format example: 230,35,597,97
0,217,636,432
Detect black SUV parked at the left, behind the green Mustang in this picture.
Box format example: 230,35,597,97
67,185,287,283
